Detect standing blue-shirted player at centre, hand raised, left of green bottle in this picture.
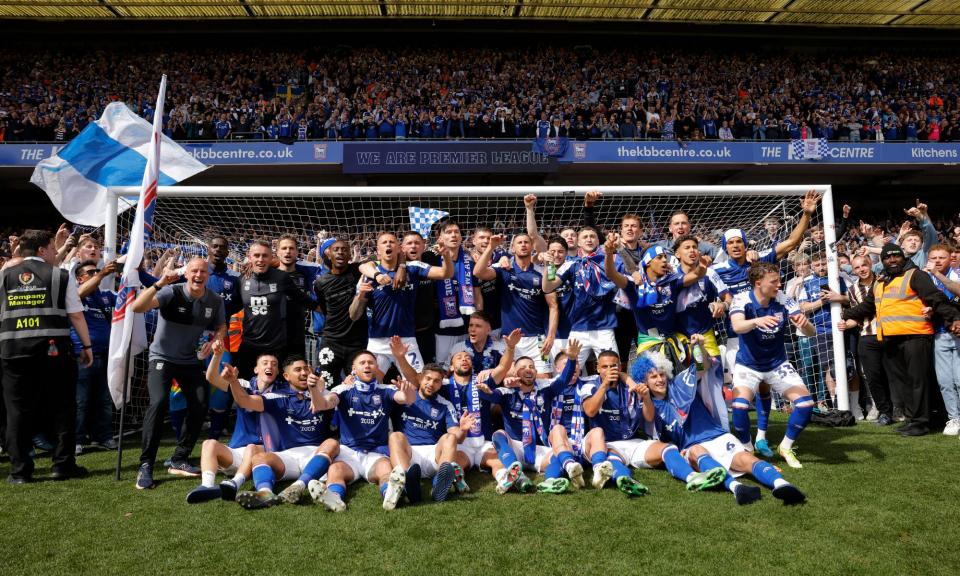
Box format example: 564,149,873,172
473,234,560,378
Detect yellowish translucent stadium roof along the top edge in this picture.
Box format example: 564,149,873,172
0,0,960,29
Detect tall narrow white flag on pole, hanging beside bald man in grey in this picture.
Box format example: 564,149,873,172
104,74,167,408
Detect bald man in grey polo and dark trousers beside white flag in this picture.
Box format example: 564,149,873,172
133,258,227,490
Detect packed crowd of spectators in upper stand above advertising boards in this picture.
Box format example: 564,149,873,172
0,45,960,142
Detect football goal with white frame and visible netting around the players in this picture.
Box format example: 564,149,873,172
104,185,849,432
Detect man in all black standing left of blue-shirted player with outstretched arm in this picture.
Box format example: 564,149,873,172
313,240,367,382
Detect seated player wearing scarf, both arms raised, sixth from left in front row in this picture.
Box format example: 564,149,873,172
477,338,584,494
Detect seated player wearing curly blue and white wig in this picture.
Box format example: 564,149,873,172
632,334,806,505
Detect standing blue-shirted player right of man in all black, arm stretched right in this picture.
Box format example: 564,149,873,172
350,232,456,372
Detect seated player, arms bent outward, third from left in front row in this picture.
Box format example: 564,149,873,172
307,342,416,512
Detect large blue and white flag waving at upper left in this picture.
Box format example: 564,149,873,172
30,102,207,226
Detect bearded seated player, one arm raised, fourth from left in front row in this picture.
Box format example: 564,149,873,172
390,336,476,503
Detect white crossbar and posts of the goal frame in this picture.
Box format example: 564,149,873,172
104,184,850,410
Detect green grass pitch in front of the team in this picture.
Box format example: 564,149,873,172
0,415,960,576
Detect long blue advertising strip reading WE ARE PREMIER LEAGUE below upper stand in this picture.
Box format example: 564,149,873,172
0,140,960,169
